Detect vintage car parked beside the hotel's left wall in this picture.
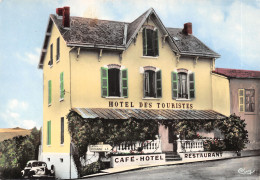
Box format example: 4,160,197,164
21,160,54,178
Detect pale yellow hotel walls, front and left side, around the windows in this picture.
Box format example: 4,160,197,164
43,20,229,153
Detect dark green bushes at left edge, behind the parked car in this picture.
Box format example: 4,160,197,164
0,128,41,178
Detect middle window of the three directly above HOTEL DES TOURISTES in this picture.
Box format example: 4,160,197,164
144,68,162,98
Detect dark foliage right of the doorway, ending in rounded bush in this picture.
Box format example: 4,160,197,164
160,114,249,151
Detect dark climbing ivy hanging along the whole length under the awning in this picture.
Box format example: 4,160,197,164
67,111,248,175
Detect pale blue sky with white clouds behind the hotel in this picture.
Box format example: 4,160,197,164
0,0,260,129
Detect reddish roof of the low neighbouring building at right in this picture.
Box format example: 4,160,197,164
213,68,260,79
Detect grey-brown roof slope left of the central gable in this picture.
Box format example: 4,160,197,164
50,14,127,47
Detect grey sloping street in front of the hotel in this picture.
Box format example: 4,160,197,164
86,156,260,180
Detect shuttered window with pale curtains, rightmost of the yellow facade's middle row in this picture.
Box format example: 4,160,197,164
172,69,195,99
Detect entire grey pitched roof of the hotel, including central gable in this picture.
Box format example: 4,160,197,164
38,8,220,68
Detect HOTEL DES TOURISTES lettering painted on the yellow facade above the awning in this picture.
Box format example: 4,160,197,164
109,101,193,109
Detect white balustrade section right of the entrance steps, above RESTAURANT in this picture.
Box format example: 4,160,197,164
177,139,204,152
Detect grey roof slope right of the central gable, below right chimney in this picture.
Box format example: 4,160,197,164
167,28,220,57
